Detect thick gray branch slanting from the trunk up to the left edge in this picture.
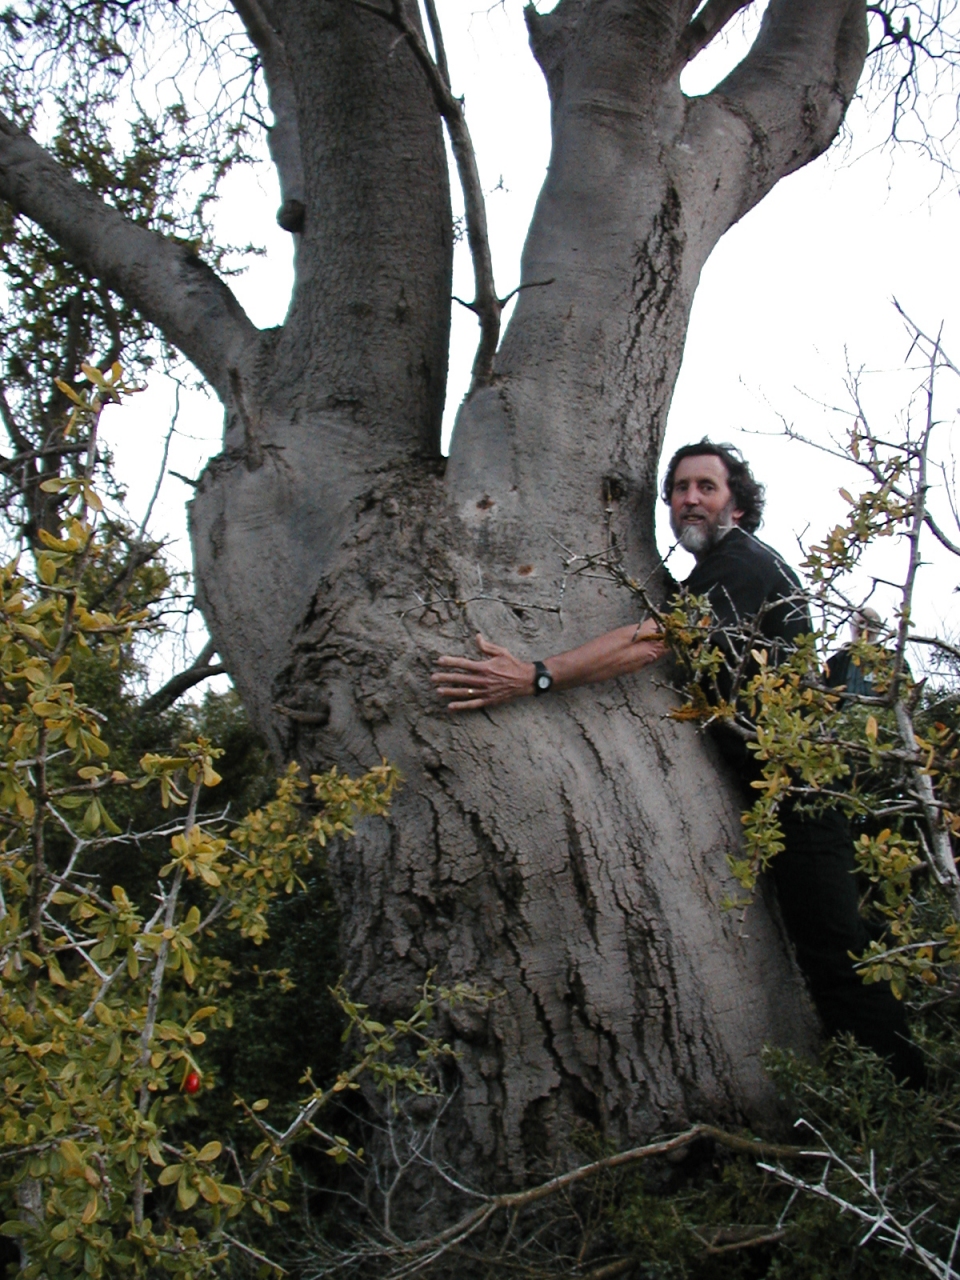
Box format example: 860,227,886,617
0,113,257,401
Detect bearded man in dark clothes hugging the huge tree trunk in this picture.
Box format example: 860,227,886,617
433,439,924,1087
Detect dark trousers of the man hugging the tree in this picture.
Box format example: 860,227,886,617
771,809,924,1088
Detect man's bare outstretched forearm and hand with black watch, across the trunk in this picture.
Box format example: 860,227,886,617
430,618,666,712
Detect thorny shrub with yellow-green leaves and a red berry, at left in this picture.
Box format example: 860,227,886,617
0,366,398,1280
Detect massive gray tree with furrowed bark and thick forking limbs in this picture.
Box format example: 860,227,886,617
0,0,865,1176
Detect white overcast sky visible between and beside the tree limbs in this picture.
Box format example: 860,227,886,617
96,0,960,680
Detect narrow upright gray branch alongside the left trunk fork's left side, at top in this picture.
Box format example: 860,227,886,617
232,0,305,232
